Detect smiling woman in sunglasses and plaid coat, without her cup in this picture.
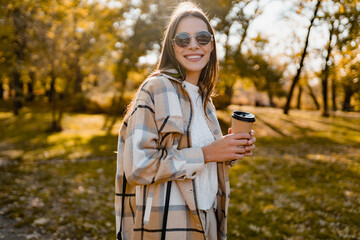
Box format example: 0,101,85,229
115,2,256,240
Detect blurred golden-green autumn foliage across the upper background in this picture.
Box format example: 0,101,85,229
0,0,359,118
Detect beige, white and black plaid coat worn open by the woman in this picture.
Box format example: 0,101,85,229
115,74,230,240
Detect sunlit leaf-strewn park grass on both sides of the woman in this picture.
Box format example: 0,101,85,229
0,104,360,239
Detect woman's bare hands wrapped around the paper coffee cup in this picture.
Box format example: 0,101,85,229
202,128,256,163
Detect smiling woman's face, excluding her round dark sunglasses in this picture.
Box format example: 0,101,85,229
173,16,214,79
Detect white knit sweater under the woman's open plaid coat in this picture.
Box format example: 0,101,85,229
183,81,218,210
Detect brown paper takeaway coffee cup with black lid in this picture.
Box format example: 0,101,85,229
231,110,255,133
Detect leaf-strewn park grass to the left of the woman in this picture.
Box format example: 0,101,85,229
0,101,119,239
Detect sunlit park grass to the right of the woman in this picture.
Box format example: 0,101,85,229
228,107,360,239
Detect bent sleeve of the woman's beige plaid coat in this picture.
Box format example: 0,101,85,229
123,94,204,185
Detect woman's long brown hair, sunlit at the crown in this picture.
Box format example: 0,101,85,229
126,2,219,120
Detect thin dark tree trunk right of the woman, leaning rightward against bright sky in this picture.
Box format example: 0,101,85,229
284,0,321,114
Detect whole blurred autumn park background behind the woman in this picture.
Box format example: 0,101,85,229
0,0,360,239
